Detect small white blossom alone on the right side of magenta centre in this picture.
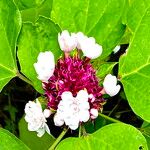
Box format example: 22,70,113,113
103,74,121,96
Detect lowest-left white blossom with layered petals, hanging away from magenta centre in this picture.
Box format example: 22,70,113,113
25,99,50,137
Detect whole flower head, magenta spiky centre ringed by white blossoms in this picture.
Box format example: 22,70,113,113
25,30,120,135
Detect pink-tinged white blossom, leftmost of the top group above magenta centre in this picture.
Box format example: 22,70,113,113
58,30,77,52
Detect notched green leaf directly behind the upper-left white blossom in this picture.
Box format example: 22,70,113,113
18,17,61,93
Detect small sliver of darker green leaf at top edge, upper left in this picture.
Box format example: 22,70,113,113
14,0,45,10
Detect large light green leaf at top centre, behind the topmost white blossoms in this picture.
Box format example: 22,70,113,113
51,0,126,58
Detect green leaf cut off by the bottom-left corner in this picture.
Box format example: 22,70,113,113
0,128,29,150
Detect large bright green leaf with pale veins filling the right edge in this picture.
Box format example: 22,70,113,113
119,0,150,122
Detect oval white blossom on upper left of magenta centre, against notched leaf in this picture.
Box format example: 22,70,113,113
34,51,55,82
